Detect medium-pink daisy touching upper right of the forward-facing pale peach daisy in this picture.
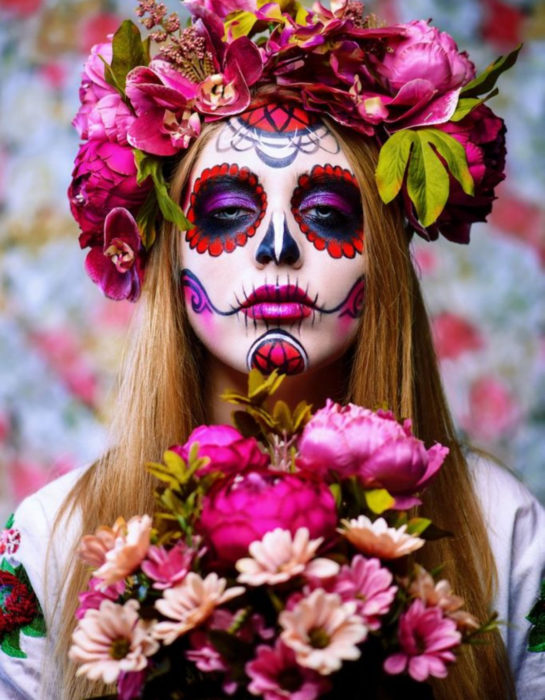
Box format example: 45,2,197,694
333,554,397,630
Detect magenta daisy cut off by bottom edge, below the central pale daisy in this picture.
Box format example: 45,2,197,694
246,640,330,700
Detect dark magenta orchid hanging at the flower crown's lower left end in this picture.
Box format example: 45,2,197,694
85,207,144,301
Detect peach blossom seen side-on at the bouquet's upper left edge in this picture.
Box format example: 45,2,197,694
79,515,152,586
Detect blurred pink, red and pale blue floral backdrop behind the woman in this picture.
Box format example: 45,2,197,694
0,0,545,517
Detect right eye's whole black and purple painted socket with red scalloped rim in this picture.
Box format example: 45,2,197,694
291,165,363,258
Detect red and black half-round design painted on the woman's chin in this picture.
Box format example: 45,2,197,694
246,328,308,374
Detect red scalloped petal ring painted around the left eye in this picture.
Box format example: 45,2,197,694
186,163,267,257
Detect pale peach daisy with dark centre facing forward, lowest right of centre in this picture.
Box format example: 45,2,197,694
278,588,367,676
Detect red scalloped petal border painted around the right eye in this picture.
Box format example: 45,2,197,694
291,165,363,258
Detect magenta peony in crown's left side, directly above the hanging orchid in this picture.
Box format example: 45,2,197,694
68,139,151,248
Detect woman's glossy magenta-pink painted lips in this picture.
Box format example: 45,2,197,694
240,284,315,322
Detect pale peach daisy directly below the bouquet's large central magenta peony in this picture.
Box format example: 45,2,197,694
235,527,339,586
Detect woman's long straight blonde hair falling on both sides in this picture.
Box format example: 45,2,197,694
51,117,515,700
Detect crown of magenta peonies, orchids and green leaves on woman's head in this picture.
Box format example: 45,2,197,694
68,0,520,301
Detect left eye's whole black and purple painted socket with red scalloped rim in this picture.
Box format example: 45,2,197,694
186,163,267,257
